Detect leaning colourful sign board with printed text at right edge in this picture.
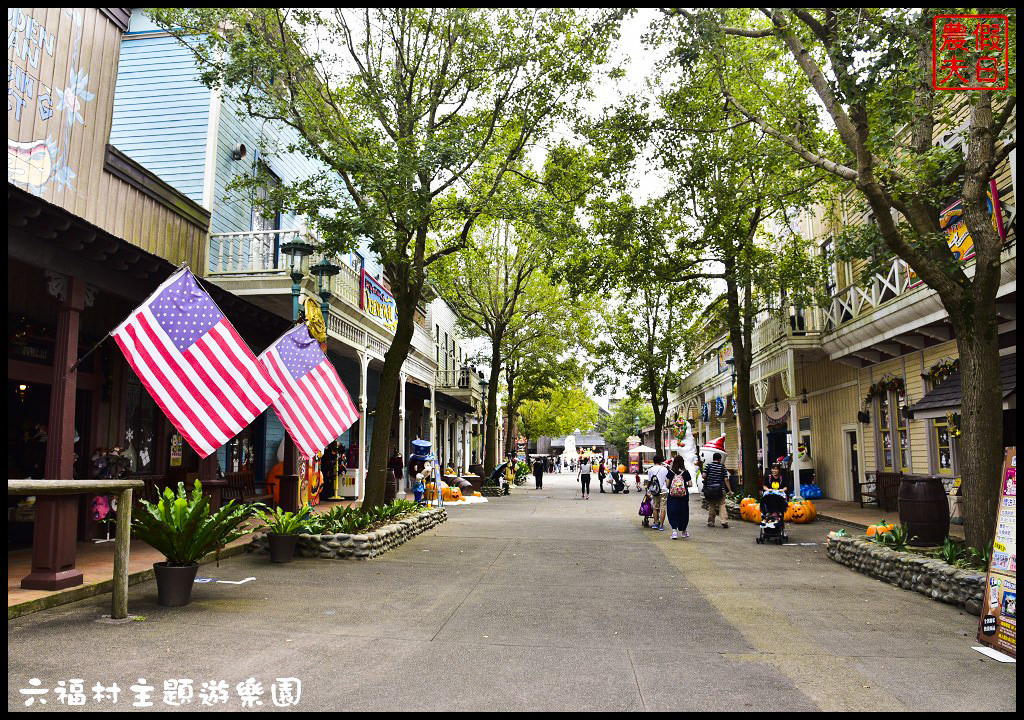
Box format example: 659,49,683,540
978,448,1017,658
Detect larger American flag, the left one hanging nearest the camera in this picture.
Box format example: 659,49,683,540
111,267,279,458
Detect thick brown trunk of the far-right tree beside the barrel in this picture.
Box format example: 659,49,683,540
949,294,1004,548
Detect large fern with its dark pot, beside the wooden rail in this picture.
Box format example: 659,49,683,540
132,480,254,607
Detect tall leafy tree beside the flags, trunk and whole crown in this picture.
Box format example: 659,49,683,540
153,8,621,506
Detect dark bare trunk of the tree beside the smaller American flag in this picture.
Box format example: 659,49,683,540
359,292,417,507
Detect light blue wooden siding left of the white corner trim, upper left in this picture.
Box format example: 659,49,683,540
111,33,210,203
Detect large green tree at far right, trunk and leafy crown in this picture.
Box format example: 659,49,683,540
674,8,1017,547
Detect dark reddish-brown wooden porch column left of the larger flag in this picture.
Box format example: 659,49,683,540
22,276,87,590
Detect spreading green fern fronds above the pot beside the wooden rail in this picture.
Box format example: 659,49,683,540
132,480,257,566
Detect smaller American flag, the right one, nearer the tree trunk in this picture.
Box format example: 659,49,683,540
259,325,359,458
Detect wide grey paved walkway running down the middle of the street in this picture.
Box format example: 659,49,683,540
7,476,1016,711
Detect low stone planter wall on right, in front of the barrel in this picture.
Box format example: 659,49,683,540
825,535,985,615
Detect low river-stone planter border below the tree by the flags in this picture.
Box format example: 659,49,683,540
249,508,447,560
